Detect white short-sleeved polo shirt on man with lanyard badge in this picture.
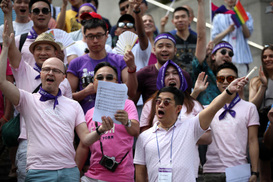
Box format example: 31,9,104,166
134,115,205,181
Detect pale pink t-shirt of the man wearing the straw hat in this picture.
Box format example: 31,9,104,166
12,60,72,139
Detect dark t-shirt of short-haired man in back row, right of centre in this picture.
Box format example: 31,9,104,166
173,33,197,75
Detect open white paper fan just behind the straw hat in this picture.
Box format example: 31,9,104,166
46,29,75,49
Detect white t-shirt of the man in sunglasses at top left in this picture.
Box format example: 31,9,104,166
0,20,33,43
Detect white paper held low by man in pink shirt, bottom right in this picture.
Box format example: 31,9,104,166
226,164,251,182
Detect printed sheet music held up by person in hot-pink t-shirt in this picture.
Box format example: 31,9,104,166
93,81,128,124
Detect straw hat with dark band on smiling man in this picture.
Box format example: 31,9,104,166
29,33,62,54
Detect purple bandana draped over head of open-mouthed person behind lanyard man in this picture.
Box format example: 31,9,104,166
156,60,188,92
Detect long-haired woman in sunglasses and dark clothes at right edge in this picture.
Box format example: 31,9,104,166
249,45,273,181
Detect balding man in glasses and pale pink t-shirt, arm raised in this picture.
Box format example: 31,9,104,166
0,23,113,181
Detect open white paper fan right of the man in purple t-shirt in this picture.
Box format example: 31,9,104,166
115,31,138,55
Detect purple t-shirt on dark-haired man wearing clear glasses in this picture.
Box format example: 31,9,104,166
67,53,126,113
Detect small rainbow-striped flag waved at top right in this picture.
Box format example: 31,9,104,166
231,1,248,27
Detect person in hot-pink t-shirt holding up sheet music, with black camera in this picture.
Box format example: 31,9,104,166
75,62,139,182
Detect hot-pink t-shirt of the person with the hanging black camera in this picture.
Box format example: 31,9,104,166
85,100,138,182
